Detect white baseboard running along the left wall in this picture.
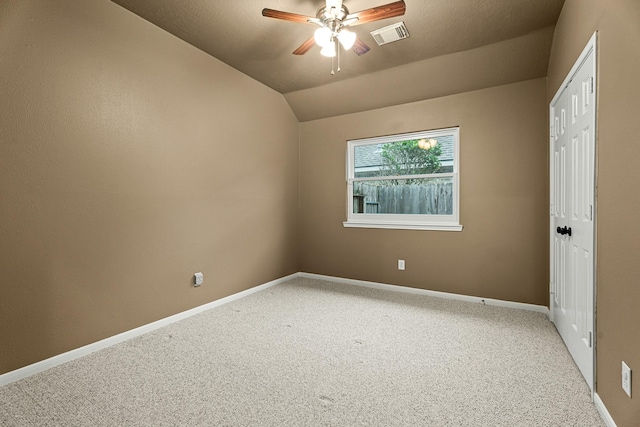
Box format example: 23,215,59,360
0,273,298,386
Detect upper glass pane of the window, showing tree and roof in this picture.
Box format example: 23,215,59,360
354,135,454,178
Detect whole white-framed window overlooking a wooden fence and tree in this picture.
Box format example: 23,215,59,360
344,127,462,231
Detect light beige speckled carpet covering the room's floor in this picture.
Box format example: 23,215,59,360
0,279,604,427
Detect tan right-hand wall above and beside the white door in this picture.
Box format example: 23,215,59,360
547,0,640,427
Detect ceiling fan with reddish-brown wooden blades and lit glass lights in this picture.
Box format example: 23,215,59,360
262,0,406,74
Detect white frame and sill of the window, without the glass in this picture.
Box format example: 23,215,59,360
343,127,462,231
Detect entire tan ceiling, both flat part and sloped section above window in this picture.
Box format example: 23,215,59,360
112,0,564,120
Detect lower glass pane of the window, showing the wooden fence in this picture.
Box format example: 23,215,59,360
353,177,453,215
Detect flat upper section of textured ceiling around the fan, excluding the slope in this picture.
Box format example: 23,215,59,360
112,0,564,95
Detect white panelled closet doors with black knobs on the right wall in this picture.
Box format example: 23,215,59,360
550,35,596,390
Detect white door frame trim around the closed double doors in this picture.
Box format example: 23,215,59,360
548,31,599,398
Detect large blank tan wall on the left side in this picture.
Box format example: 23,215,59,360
0,0,298,374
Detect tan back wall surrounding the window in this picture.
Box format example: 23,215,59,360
300,79,548,305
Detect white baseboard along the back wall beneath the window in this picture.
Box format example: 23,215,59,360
298,273,550,318
